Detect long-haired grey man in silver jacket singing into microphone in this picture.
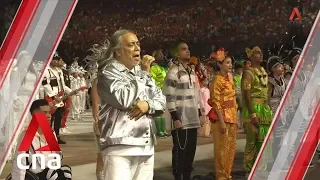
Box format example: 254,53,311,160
97,30,166,180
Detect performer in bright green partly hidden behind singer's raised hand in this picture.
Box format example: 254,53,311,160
150,50,168,138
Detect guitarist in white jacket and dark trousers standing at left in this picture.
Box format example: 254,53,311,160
42,52,72,144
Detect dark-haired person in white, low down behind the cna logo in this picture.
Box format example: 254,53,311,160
7,99,72,180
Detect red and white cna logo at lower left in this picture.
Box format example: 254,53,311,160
17,113,61,169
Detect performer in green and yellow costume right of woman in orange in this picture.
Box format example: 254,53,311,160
241,46,273,173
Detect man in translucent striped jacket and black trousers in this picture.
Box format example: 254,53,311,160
163,43,200,180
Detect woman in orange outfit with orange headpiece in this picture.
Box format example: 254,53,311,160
210,54,238,180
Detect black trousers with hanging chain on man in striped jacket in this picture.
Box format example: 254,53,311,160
171,128,198,180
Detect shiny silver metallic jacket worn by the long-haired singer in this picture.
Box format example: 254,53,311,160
97,60,166,150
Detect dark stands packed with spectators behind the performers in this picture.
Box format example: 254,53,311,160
1,0,320,65
